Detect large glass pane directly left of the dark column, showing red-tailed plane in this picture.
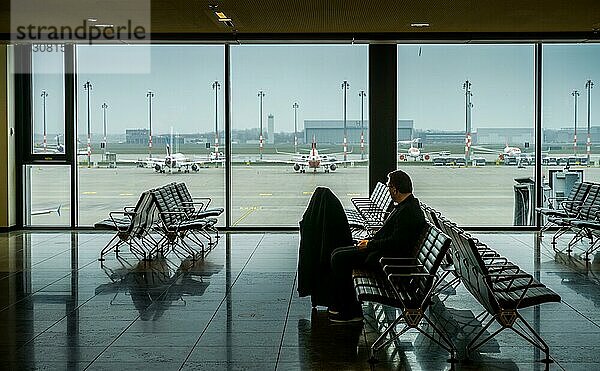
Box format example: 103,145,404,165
230,45,368,226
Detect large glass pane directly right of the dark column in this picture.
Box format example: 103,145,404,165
398,45,535,226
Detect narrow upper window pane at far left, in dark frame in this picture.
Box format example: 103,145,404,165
32,44,65,154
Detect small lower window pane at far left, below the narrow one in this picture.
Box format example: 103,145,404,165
23,165,71,226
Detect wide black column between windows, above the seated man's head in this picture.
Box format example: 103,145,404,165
369,44,398,193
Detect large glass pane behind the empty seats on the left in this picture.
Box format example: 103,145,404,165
77,45,225,225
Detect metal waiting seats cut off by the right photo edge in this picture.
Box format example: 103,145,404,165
536,182,600,261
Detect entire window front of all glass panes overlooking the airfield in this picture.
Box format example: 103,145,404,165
17,44,600,227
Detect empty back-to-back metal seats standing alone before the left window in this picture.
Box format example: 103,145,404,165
94,183,224,261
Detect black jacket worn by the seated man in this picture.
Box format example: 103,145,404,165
367,194,425,264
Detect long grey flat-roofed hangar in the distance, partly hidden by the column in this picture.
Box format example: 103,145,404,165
304,120,414,144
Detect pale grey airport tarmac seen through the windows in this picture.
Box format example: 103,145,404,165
24,163,600,226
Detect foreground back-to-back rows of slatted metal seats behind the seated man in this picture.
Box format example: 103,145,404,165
353,204,560,363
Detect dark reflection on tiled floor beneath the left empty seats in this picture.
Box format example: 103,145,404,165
95,258,223,321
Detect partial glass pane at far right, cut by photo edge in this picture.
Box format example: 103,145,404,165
542,44,600,206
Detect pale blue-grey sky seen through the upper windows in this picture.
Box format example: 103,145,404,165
34,44,600,138
